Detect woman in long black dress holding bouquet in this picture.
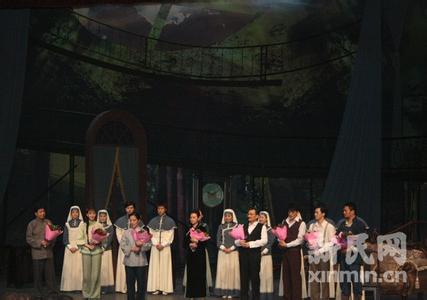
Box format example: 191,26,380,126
185,211,207,298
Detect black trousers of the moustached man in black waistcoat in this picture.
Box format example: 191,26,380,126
239,248,261,300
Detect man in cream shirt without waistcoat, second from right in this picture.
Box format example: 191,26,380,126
308,203,335,300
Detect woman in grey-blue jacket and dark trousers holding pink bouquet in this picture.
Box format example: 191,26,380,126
120,212,151,300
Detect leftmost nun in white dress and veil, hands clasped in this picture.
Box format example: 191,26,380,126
60,206,86,292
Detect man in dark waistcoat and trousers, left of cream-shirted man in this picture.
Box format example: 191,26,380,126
279,204,306,300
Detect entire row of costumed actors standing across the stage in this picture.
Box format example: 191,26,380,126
27,202,367,300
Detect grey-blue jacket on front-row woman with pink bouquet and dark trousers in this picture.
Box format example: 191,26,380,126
120,228,151,267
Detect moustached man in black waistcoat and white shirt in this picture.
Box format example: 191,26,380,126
234,208,268,300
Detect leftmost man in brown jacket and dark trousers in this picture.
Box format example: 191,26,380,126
26,206,58,297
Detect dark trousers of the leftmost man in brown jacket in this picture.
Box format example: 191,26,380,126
33,258,57,295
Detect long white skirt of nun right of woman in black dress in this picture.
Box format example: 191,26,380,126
215,250,240,296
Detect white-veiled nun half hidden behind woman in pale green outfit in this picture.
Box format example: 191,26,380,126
97,209,114,293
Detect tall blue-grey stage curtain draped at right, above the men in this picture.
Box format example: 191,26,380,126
322,0,382,228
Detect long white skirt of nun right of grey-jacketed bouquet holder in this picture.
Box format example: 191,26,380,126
147,247,173,293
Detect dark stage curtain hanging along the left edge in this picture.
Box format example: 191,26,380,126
0,9,30,231
